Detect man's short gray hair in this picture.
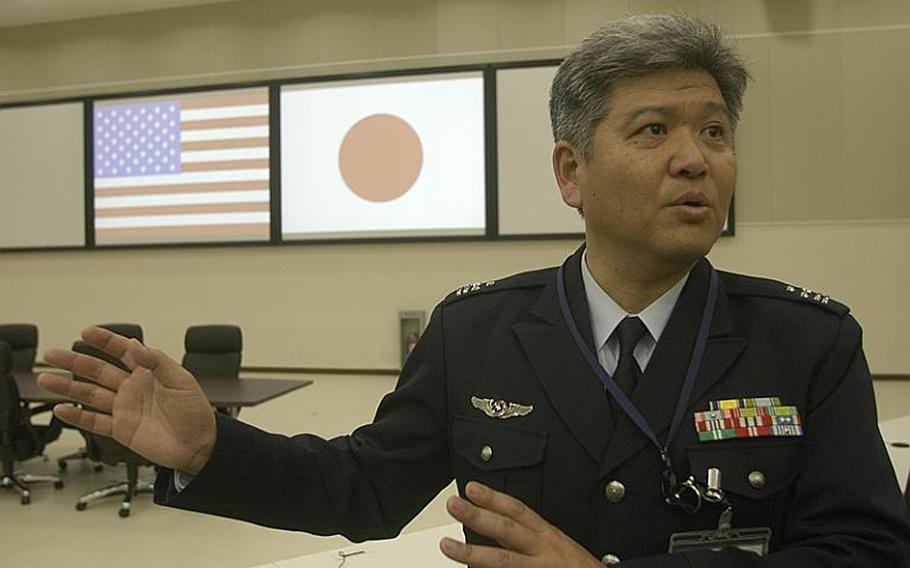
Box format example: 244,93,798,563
550,14,749,160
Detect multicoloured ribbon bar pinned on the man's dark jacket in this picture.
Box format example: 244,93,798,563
693,397,803,442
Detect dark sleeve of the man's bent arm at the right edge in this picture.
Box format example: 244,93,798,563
621,315,910,568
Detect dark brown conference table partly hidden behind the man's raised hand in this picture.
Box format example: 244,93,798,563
13,371,313,407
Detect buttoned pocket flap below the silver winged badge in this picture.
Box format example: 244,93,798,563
452,416,547,471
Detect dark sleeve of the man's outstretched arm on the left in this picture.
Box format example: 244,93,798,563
155,308,452,542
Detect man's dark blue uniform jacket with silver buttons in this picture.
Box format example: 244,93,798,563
156,251,910,568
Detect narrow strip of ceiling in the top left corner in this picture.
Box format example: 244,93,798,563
0,0,242,28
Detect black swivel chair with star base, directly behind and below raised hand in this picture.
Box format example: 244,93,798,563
73,341,154,517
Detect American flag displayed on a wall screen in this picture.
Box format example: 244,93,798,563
94,88,269,244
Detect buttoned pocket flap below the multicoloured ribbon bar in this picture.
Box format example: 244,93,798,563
686,439,801,499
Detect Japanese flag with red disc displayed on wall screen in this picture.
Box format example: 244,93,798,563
281,73,485,238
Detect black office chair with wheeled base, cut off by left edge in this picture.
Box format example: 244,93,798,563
0,341,63,505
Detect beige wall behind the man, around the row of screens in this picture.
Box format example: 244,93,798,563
0,0,910,374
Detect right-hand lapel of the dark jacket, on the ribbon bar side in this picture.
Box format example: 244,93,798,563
602,259,746,474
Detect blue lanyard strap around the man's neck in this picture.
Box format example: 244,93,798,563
556,260,717,464
